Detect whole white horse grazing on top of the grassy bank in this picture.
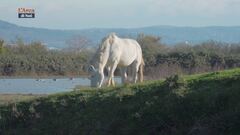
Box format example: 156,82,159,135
89,33,144,87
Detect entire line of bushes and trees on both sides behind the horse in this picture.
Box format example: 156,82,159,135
0,34,240,79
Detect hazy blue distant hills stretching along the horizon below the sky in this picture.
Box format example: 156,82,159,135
0,20,240,48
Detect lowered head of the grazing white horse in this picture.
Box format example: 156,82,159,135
88,65,103,87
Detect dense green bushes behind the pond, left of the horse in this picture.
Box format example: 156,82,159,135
0,40,90,76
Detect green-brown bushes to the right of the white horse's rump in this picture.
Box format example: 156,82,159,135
137,34,240,79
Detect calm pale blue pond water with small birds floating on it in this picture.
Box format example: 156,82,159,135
0,77,119,94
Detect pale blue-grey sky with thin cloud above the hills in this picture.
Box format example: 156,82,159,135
0,0,240,29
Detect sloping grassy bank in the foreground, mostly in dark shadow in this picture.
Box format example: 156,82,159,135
0,68,240,135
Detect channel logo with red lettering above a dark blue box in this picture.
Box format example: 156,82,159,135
17,8,35,18
